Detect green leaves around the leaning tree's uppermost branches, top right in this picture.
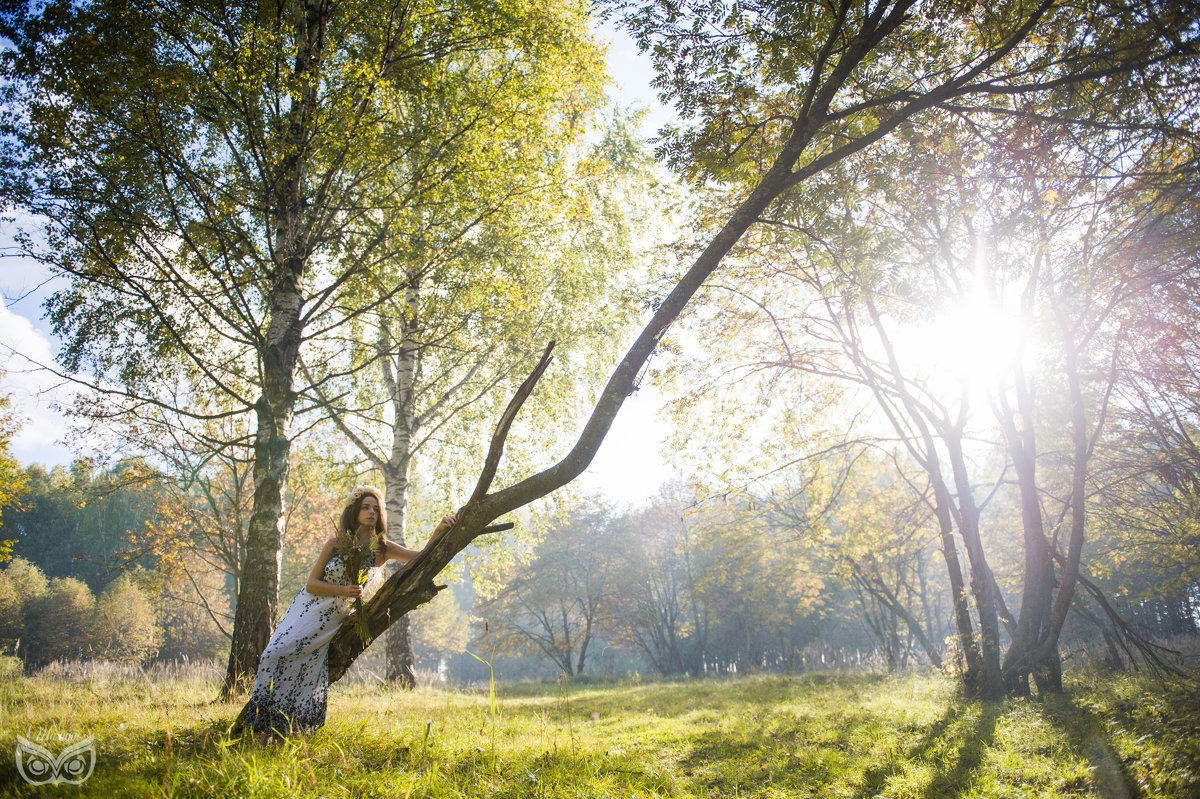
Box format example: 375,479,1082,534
605,0,1195,190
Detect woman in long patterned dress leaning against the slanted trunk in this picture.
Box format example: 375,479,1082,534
240,486,456,743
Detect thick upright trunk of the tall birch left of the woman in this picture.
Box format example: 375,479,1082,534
221,2,329,697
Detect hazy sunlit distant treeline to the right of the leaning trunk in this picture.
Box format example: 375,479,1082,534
474,482,1200,678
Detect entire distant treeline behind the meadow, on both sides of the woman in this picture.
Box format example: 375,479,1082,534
0,453,1200,681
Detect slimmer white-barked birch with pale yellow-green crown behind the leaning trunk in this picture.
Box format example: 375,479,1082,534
312,113,649,686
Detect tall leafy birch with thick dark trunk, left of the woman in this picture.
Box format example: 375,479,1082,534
0,0,594,691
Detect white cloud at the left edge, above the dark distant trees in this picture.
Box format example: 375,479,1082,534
0,304,74,465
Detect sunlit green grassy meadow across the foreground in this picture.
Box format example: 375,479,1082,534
0,657,1200,798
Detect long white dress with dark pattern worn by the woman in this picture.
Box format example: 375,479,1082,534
245,542,378,735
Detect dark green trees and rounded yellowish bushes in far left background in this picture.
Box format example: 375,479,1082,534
0,462,227,667
